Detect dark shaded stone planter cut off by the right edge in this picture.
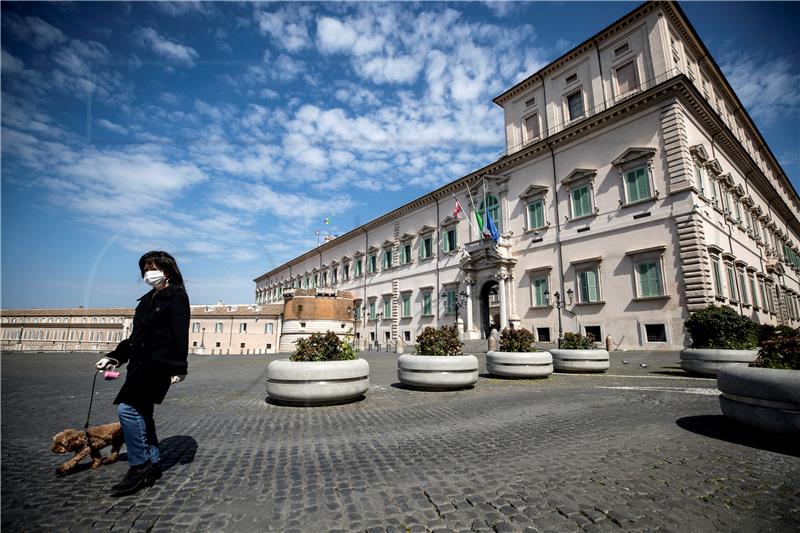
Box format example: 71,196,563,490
717,365,800,434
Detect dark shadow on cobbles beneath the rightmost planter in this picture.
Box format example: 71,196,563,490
675,415,800,457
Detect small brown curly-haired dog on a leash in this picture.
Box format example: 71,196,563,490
53,422,125,475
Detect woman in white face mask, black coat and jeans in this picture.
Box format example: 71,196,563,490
95,252,189,496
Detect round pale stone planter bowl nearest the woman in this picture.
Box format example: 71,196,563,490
267,359,369,405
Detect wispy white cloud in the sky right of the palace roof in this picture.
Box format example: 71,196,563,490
721,55,800,123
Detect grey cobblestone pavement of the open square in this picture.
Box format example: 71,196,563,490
1,352,800,532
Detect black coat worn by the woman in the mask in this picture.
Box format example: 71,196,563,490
107,285,189,406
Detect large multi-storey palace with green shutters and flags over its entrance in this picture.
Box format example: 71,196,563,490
255,2,800,349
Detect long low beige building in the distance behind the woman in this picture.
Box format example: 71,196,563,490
0,302,283,355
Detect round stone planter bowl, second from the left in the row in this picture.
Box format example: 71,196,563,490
397,354,478,390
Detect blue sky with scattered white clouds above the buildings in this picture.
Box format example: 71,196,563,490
0,2,800,308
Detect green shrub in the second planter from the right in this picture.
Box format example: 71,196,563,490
683,305,759,350
